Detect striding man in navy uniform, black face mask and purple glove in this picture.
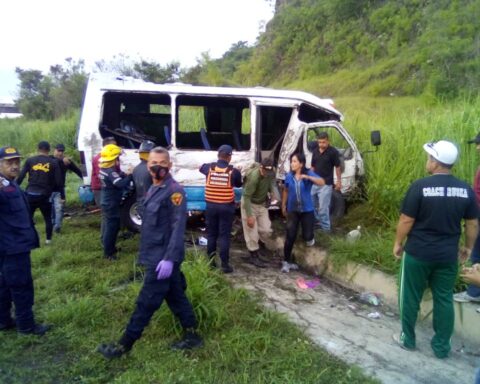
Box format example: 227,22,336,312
98,147,203,359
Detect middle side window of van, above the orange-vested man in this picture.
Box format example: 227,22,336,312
175,96,251,151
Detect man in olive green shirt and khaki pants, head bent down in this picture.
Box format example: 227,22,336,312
240,158,280,268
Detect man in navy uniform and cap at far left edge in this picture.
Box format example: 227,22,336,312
0,147,50,336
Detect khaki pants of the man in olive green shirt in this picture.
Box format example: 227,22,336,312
240,198,276,251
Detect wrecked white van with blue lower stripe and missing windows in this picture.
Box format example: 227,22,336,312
77,74,379,227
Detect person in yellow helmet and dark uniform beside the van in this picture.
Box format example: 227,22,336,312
98,144,132,260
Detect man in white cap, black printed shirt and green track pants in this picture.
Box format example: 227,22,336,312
393,140,478,359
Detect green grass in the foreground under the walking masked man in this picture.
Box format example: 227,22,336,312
0,210,376,384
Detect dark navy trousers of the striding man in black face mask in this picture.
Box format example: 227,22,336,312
125,263,197,341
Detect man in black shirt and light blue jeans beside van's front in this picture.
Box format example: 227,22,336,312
311,132,342,232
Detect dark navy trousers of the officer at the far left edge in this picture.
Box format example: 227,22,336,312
0,252,35,330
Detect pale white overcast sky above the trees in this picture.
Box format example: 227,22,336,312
0,0,274,100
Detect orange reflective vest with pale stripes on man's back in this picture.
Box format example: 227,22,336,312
205,163,235,204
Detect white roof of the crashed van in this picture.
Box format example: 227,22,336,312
89,73,343,120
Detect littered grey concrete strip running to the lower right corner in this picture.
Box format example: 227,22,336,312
218,245,480,384
